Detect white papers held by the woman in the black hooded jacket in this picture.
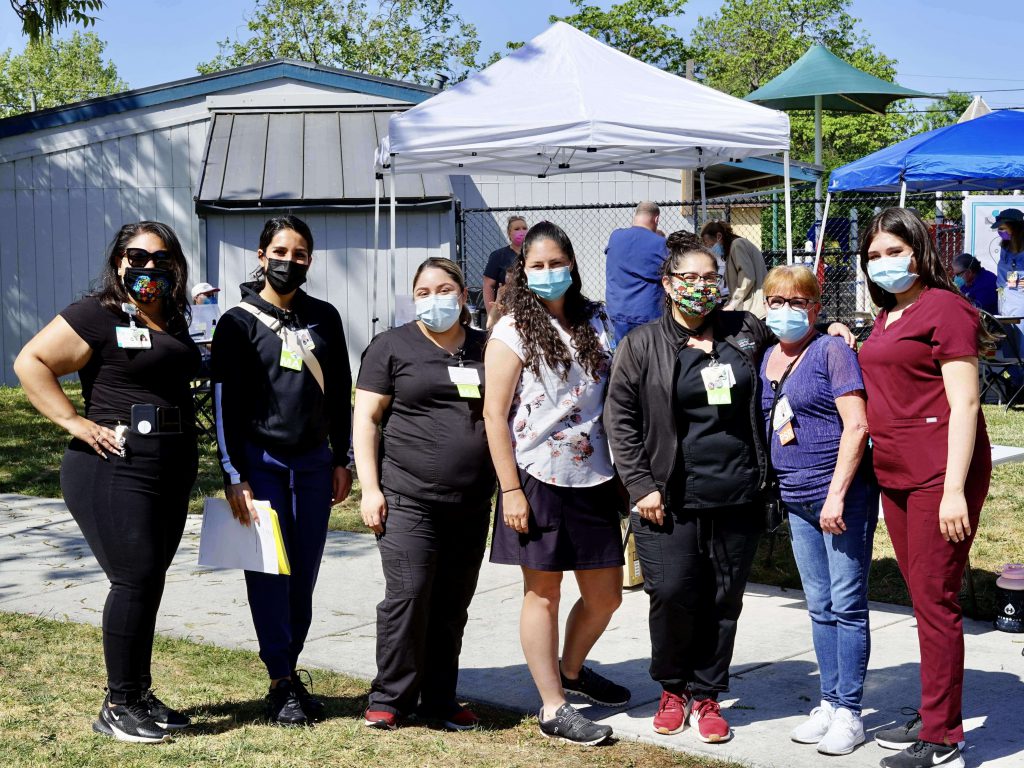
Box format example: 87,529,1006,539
199,499,281,573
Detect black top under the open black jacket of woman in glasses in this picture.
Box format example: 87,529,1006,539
672,341,758,508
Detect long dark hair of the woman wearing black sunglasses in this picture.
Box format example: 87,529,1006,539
91,221,191,326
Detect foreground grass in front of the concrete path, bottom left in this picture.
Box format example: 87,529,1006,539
0,613,726,768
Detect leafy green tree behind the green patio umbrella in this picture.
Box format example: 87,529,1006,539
690,0,915,174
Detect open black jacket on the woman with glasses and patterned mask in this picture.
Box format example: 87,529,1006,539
604,309,775,506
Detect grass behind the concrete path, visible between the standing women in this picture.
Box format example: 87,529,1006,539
0,384,1024,617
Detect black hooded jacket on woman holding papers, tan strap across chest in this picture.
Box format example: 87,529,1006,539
211,283,352,483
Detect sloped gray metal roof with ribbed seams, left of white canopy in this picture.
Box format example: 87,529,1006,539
196,108,452,210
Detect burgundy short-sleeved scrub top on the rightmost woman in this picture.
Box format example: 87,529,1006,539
860,288,991,489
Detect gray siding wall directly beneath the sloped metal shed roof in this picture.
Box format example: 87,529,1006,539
206,209,455,372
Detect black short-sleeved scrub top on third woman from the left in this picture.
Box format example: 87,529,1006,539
355,322,495,503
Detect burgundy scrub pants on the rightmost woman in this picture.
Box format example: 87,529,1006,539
882,456,991,744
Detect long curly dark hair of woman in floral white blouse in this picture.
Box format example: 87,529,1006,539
502,221,608,381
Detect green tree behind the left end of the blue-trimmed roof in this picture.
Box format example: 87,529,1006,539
0,32,128,118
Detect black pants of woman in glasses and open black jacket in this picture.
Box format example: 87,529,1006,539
631,504,764,699
